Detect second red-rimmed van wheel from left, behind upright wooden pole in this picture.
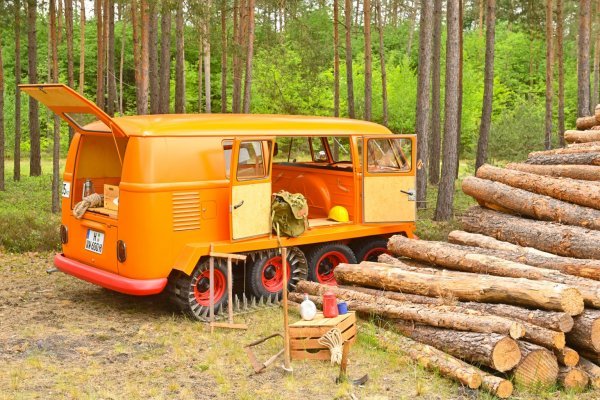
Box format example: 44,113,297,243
248,247,307,298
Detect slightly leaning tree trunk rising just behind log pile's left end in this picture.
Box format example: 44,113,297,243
475,0,496,169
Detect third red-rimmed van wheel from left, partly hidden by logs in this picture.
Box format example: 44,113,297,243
306,243,356,285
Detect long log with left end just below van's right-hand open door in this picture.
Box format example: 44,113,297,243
388,235,600,315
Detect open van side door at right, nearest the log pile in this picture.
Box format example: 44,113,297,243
362,135,417,223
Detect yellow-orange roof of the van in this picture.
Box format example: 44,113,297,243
83,114,392,137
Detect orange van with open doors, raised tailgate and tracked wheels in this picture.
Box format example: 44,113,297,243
20,84,416,319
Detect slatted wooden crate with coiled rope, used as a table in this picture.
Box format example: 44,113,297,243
290,311,356,360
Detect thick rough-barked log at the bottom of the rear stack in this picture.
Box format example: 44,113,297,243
461,207,600,259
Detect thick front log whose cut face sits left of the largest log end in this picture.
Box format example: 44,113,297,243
393,321,521,372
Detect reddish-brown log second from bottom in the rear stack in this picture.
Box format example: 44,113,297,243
462,176,600,230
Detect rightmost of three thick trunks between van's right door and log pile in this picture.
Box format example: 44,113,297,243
434,0,461,221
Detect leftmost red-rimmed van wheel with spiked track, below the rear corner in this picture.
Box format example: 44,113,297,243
168,260,227,321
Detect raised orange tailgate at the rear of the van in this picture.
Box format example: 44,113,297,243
19,84,126,137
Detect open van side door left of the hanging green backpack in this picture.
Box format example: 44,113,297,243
229,138,273,240
